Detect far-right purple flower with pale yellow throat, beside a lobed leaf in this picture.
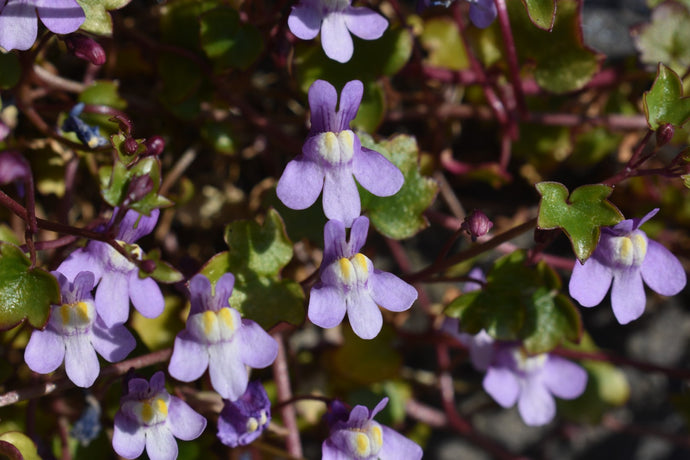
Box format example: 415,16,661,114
569,208,686,324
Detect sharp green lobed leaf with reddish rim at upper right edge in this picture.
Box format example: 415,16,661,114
642,64,690,130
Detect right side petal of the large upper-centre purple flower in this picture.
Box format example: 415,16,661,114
352,147,405,196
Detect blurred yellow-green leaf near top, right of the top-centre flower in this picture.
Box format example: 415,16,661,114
419,17,470,70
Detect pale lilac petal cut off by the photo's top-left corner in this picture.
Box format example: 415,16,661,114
0,0,38,51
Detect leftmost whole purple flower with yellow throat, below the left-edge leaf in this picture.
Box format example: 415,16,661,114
24,272,136,387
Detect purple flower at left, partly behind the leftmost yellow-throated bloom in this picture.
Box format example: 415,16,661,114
57,209,164,326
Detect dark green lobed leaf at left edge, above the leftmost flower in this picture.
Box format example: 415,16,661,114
0,242,60,330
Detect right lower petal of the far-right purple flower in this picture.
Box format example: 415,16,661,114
640,240,687,295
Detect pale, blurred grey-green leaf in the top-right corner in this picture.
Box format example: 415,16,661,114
632,2,690,74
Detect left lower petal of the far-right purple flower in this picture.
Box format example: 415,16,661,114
568,254,613,307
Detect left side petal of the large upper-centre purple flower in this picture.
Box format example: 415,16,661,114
276,156,324,209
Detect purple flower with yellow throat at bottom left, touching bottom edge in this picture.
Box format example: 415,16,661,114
113,371,206,460
